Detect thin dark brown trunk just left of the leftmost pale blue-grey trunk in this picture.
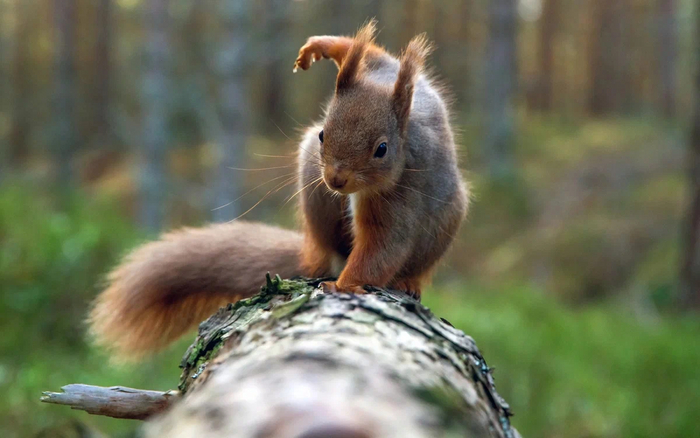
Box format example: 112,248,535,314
94,0,112,140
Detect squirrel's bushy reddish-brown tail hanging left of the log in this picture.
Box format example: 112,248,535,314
88,222,302,360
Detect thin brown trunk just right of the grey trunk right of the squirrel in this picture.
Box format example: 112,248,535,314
536,0,559,112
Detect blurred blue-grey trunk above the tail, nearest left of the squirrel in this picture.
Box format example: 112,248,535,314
208,0,251,221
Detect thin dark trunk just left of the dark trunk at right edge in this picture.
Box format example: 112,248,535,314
657,0,678,117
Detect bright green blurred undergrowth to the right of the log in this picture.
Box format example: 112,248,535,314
424,284,700,437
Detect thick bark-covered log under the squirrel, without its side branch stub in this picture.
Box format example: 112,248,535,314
146,276,517,438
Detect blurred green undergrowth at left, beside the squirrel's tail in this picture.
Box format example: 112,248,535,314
0,183,186,438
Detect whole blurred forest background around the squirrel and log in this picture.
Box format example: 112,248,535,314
0,0,700,437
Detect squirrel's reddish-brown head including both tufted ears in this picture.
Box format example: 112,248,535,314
319,21,429,194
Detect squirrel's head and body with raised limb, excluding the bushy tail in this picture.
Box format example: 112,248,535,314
300,22,468,295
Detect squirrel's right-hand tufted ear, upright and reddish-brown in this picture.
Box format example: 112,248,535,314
392,34,432,134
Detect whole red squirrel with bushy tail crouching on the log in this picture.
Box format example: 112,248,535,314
88,20,469,359
